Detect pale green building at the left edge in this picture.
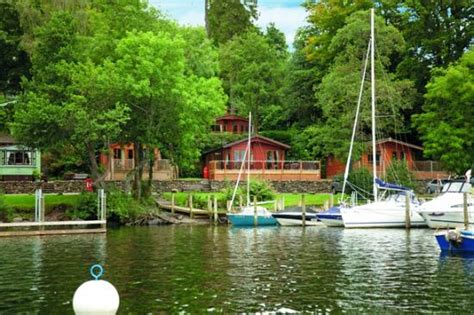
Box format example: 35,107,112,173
0,134,41,181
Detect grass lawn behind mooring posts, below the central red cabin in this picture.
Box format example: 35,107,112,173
161,192,338,209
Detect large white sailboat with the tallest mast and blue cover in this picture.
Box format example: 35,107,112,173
340,9,426,228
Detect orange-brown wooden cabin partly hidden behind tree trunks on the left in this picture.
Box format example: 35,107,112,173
100,143,177,180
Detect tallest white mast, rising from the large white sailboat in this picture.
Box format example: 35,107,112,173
370,9,378,202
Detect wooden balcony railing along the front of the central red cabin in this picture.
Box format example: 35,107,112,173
209,160,321,181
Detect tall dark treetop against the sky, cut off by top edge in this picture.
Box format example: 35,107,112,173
205,0,257,45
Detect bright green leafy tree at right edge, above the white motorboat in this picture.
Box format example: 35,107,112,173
413,50,474,174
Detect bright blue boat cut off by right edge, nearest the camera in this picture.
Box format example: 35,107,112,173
435,230,474,253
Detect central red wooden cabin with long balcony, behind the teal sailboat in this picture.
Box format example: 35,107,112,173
203,135,321,180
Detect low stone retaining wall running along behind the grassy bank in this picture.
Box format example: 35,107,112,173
0,179,425,194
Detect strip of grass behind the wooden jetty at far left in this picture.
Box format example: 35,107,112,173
3,195,79,212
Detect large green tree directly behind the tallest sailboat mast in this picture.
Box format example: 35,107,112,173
292,11,414,162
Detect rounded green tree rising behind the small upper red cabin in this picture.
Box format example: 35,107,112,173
220,32,286,130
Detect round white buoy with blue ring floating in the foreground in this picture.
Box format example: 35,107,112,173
72,265,120,315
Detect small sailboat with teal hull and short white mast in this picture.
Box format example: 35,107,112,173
227,113,277,226
